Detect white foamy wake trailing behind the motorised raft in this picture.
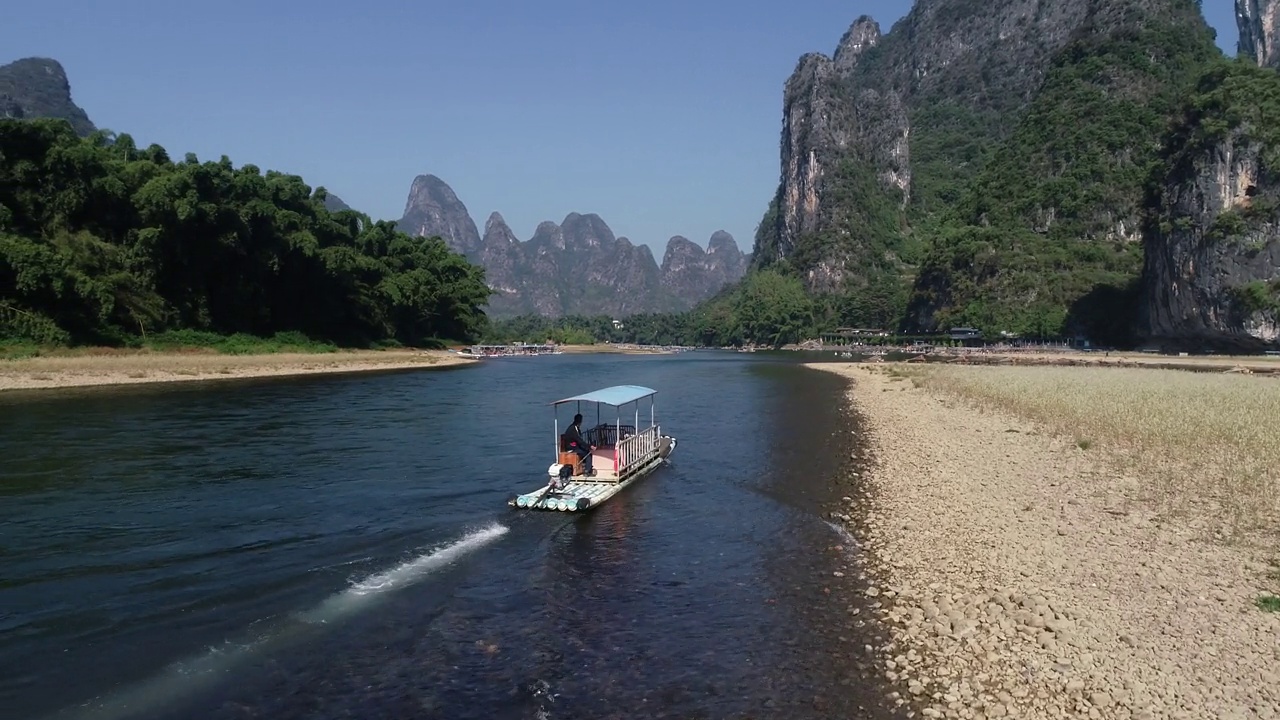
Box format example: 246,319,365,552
50,523,507,720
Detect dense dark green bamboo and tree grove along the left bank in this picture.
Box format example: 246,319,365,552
0,119,489,347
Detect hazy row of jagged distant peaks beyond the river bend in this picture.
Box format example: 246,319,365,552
397,174,750,318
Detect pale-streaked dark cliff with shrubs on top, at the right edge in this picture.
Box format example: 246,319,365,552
1142,65,1280,352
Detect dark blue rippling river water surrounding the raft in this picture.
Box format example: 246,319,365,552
0,351,901,720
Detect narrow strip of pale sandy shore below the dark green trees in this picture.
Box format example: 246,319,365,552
0,350,477,393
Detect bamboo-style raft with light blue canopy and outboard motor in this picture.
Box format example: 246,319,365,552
507,386,676,511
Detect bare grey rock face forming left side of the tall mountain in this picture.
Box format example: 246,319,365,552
754,0,1091,291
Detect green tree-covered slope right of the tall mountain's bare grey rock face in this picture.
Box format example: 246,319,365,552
906,3,1221,342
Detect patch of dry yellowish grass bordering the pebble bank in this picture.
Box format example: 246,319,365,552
896,365,1280,541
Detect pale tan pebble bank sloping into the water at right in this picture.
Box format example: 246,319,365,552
812,363,1280,719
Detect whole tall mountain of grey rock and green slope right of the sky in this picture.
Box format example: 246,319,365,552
755,0,1221,342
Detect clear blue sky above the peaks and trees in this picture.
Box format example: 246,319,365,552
0,0,1236,261
